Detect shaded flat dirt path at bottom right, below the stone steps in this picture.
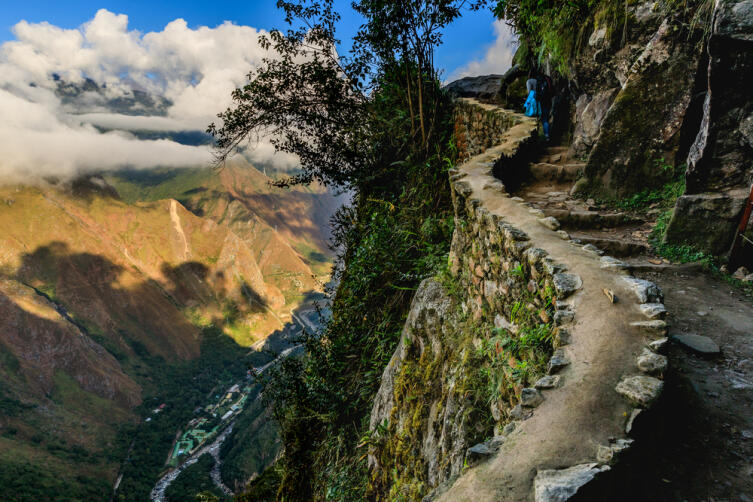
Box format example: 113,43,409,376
624,268,753,502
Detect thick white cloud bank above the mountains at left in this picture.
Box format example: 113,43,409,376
0,9,296,182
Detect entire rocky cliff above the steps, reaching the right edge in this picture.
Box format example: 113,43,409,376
571,0,753,255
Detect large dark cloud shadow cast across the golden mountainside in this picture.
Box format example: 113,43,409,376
9,242,268,360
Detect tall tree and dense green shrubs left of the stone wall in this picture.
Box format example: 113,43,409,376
210,0,482,501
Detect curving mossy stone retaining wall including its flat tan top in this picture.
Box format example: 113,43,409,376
369,100,667,502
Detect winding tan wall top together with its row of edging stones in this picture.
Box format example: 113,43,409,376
437,103,664,502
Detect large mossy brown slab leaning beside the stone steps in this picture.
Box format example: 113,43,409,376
584,18,700,194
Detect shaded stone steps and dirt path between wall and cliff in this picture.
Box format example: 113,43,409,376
476,123,753,502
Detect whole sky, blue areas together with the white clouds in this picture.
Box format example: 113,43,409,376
0,0,515,179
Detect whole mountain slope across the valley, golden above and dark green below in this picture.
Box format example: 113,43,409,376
0,166,336,500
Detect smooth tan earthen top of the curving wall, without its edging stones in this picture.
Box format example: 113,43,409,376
439,121,664,502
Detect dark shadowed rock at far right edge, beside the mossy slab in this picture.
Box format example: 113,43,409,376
666,0,753,254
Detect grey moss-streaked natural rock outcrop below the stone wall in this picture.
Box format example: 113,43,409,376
369,279,473,486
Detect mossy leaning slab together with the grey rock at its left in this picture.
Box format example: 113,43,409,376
570,2,702,192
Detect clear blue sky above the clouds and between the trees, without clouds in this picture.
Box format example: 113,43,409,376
0,0,504,75
